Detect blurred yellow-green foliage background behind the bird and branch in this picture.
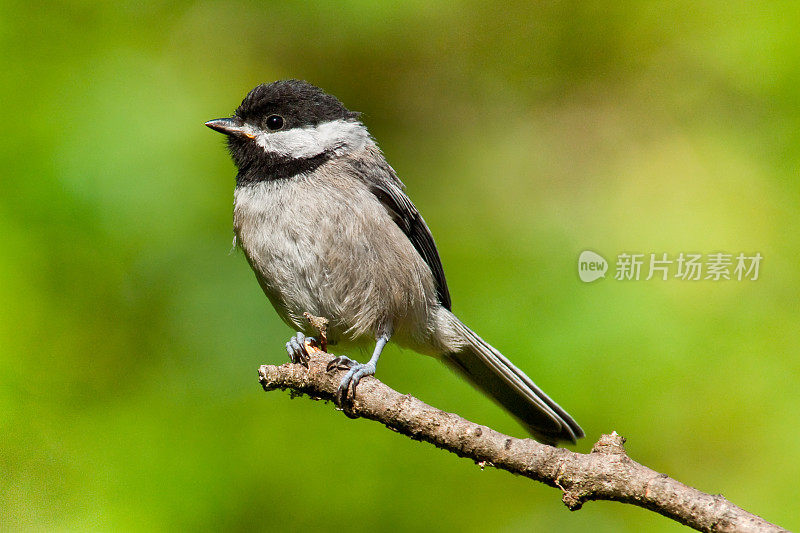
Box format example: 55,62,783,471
0,0,800,531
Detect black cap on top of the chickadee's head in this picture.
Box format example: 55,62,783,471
231,80,358,130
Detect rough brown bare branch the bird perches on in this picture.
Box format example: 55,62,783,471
258,350,787,532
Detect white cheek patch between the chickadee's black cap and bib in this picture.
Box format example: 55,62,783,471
252,120,369,159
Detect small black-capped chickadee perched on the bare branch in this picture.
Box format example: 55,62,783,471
205,80,583,444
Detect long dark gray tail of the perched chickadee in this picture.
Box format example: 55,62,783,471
444,317,584,446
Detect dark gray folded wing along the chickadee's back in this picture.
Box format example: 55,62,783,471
350,156,451,311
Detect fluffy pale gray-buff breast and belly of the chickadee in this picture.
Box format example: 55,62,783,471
234,177,435,344
